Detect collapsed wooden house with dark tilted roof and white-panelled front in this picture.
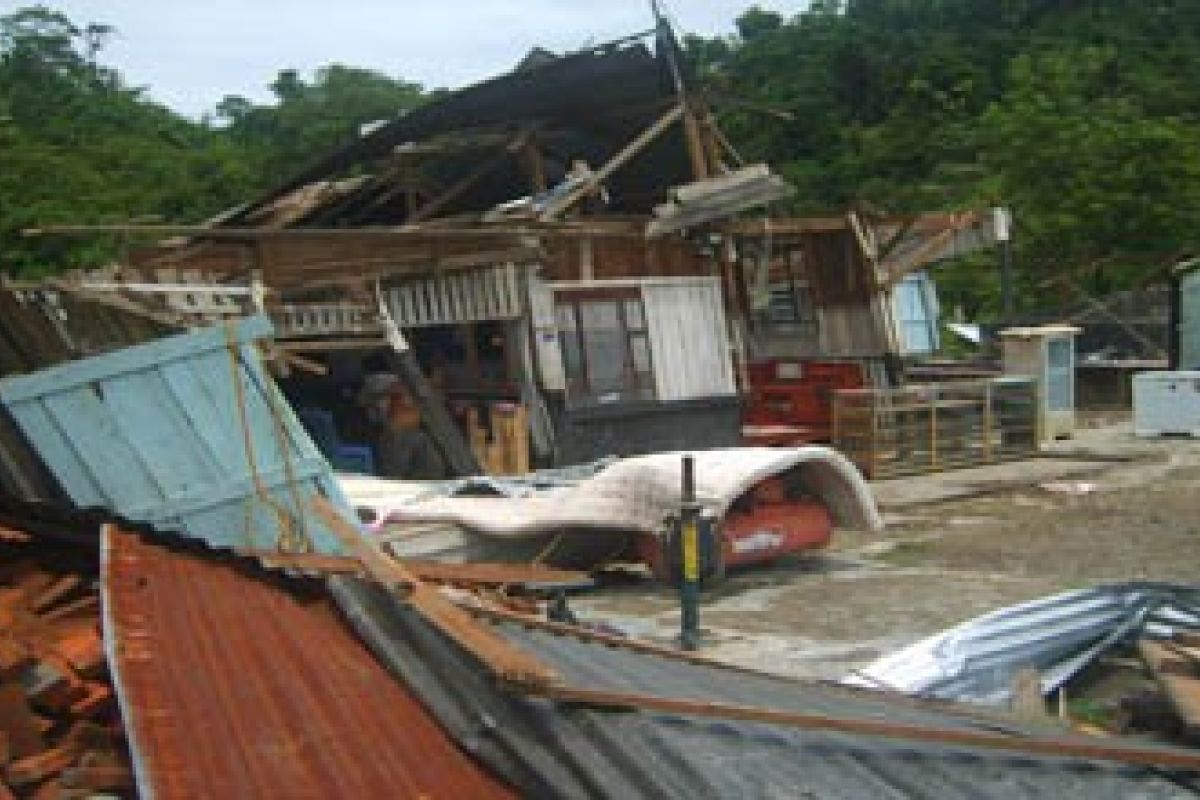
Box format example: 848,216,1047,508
25,26,991,473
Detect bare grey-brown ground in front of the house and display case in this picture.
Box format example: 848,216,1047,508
572,425,1200,678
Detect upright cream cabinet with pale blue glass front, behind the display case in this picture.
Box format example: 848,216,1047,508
1000,325,1080,441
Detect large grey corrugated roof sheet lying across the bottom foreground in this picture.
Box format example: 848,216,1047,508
331,578,1198,800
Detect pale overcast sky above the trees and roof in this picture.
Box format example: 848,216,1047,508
37,0,806,116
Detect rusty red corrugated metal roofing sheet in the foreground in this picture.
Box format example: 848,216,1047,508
103,529,516,800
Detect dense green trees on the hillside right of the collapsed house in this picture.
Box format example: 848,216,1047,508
688,0,1200,314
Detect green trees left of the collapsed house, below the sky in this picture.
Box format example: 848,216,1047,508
0,6,422,275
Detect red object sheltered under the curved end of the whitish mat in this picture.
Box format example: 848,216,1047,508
637,476,833,583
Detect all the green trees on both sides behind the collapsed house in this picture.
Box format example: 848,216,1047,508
0,0,1200,315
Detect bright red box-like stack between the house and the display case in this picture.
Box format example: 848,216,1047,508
742,359,866,446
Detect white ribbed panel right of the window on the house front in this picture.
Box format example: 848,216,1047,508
642,278,737,402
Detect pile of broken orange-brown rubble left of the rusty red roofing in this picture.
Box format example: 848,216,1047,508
0,539,133,800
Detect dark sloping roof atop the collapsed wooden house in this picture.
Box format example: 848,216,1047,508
231,43,691,225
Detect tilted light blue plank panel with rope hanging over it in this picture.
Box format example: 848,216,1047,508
0,317,354,553
